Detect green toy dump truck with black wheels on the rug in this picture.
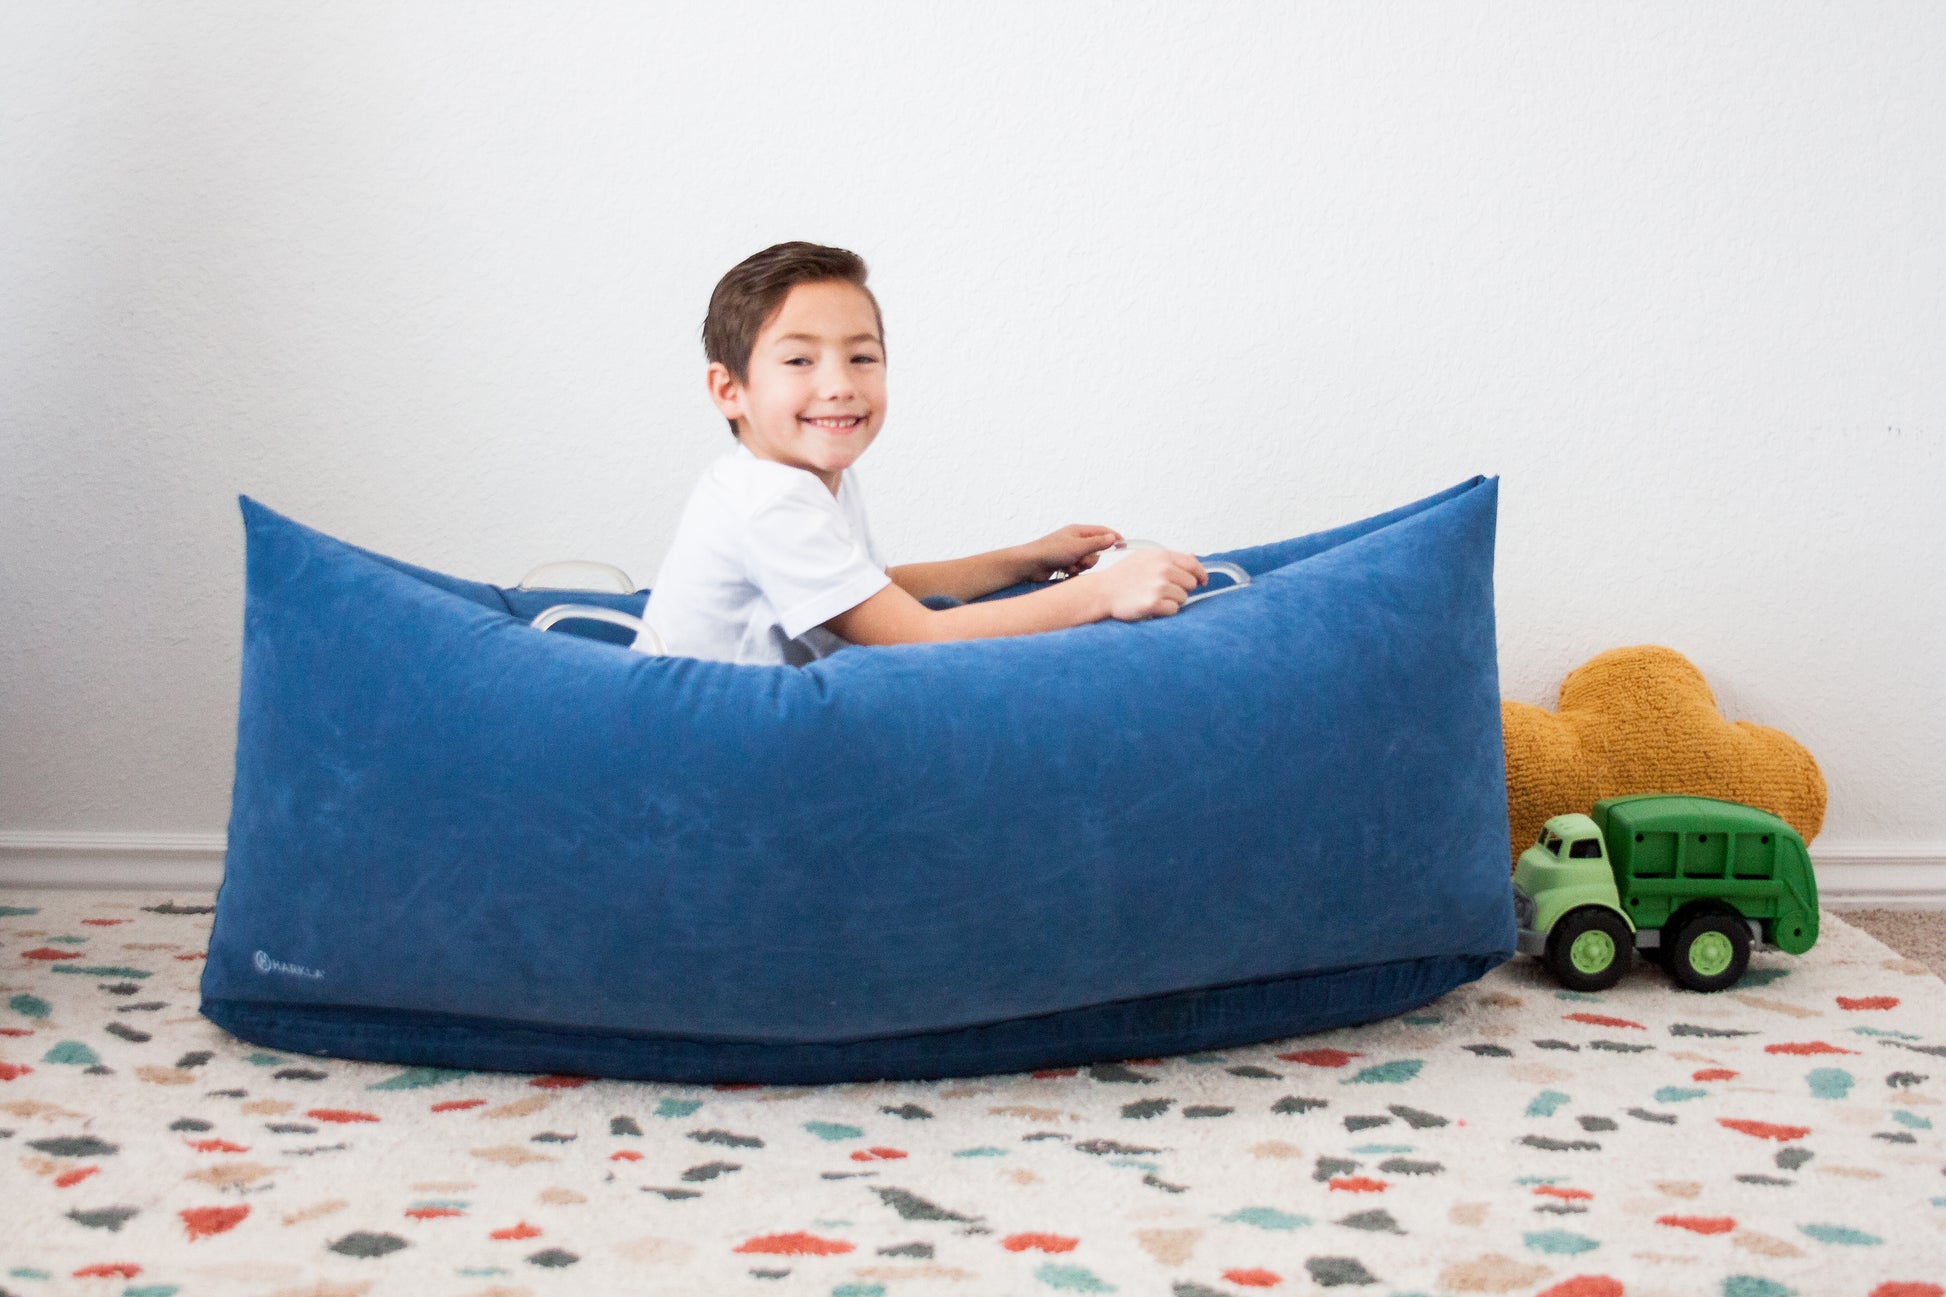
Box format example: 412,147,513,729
1514,793,1818,991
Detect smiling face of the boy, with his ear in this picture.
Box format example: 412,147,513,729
708,280,885,495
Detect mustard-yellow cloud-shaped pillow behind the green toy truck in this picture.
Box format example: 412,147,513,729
1500,645,1825,857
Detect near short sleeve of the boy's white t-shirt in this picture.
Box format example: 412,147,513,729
745,473,891,639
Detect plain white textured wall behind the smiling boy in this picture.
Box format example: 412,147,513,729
0,0,1946,853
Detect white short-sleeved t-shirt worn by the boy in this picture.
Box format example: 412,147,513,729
634,444,891,666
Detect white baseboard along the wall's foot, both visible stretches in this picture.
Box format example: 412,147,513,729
0,830,1946,909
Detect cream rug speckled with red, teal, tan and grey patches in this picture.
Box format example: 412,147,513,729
0,892,1946,1297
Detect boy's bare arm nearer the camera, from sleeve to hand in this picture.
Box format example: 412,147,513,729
825,549,1208,645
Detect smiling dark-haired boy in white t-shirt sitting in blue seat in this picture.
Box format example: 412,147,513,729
636,241,1208,666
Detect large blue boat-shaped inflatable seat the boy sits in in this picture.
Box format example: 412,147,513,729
202,477,1514,1083
